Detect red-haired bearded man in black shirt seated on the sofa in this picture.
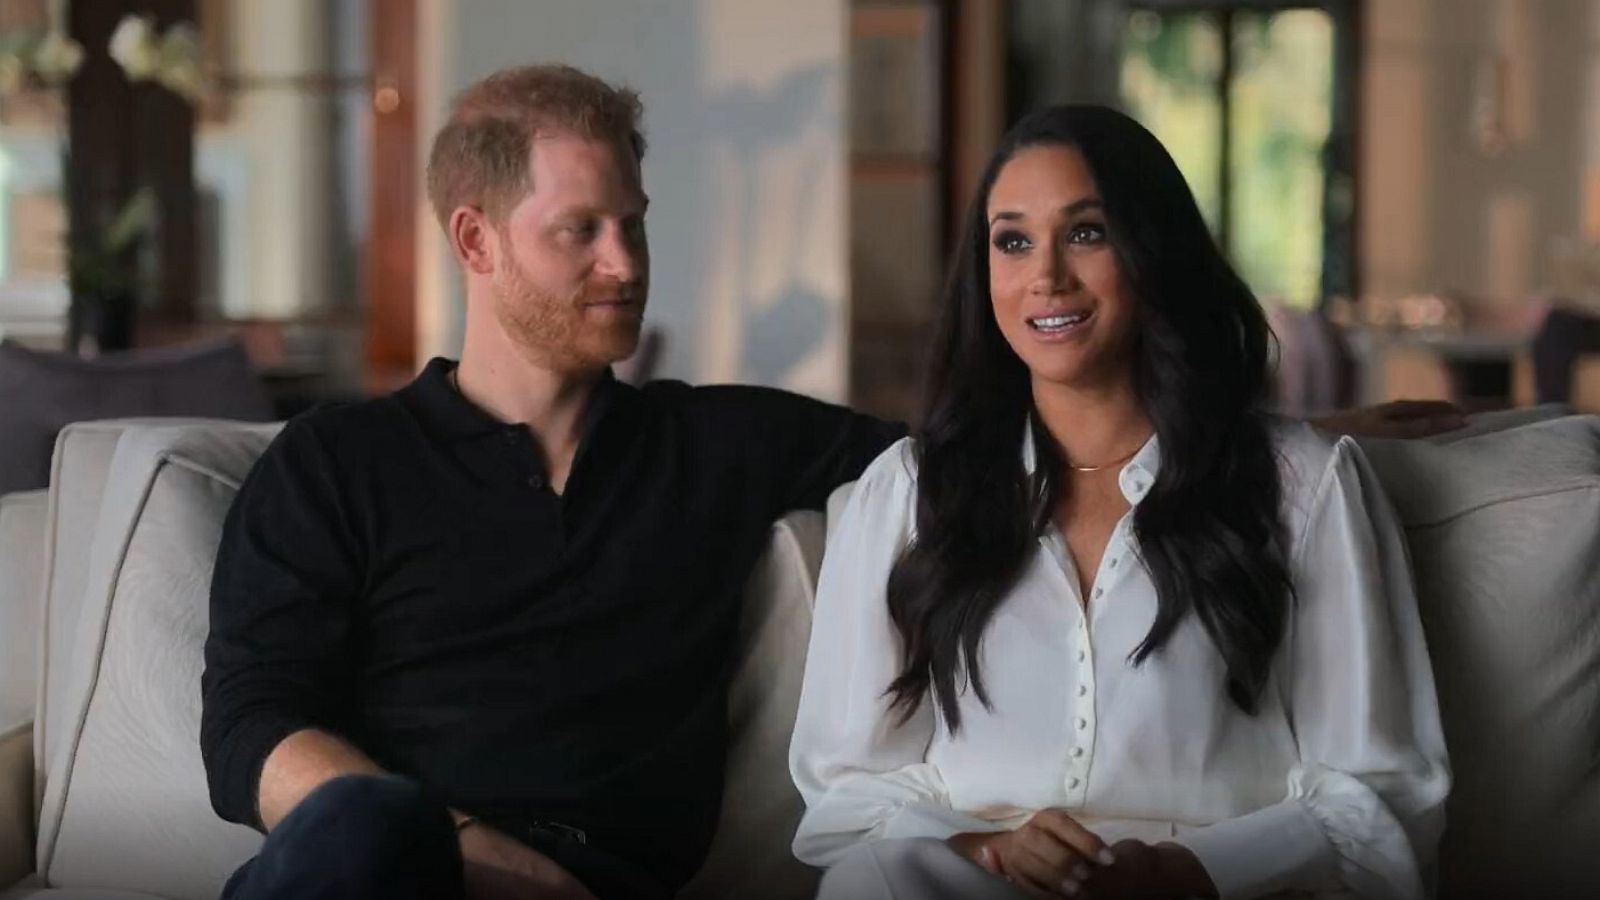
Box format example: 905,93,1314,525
202,67,902,900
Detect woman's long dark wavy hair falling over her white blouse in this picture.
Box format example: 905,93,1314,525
888,106,1293,732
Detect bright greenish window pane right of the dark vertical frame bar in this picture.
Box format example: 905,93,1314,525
1229,10,1333,309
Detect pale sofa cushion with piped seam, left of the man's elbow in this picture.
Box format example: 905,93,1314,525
38,424,275,900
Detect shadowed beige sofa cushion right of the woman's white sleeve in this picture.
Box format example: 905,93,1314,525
1363,416,1600,897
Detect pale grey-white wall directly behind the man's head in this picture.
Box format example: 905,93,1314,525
418,0,846,399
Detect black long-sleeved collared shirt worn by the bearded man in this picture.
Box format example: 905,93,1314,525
202,359,902,886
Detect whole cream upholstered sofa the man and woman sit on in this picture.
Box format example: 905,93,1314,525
0,413,1600,900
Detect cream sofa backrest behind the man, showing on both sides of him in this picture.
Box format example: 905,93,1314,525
38,423,822,900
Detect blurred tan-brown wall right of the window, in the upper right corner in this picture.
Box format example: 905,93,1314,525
1360,0,1600,304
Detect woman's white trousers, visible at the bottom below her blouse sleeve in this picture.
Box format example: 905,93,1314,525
818,838,1029,900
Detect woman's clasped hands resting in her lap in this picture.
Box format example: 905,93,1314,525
947,809,1114,898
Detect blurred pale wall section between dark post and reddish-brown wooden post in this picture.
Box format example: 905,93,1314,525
195,0,368,320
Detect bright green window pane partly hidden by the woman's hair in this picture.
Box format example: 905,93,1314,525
1122,10,1222,231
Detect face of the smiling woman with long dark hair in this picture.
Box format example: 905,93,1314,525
987,144,1134,388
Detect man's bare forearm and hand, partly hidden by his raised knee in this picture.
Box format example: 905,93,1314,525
256,729,594,900
